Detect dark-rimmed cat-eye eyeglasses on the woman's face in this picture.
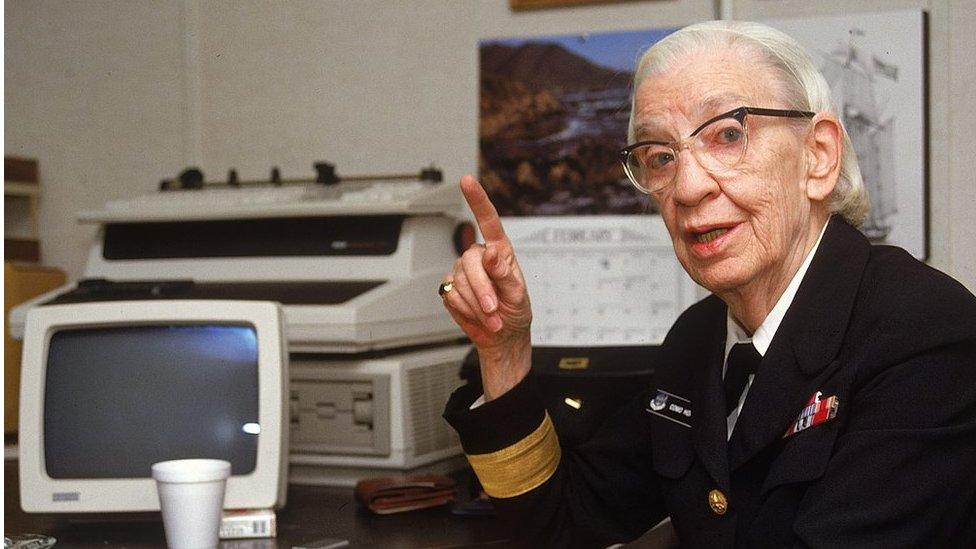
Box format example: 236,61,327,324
620,107,814,194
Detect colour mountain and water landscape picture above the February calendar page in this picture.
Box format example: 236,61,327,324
478,29,676,216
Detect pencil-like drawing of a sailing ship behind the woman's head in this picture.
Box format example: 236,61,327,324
820,29,898,242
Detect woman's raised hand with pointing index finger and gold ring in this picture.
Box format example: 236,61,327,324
444,175,532,400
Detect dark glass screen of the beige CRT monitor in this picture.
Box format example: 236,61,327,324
44,324,260,479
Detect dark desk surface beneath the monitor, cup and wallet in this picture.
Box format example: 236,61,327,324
3,461,506,549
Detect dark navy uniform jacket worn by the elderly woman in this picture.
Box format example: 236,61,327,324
445,216,976,547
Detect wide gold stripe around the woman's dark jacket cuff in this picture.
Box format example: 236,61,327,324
467,412,561,498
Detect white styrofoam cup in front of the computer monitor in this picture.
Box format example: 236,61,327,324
152,459,230,549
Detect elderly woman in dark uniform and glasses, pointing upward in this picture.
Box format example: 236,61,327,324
441,22,976,547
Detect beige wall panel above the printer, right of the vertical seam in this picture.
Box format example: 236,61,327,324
191,0,713,203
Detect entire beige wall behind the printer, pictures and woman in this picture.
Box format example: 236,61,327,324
5,0,976,289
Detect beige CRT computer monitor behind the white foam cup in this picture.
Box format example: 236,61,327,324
19,300,288,513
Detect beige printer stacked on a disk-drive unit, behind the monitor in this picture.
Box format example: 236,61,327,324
9,164,474,485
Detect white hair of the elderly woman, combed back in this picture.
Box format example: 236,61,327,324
628,21,869,226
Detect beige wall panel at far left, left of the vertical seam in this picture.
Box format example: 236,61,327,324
4,0,185,278
